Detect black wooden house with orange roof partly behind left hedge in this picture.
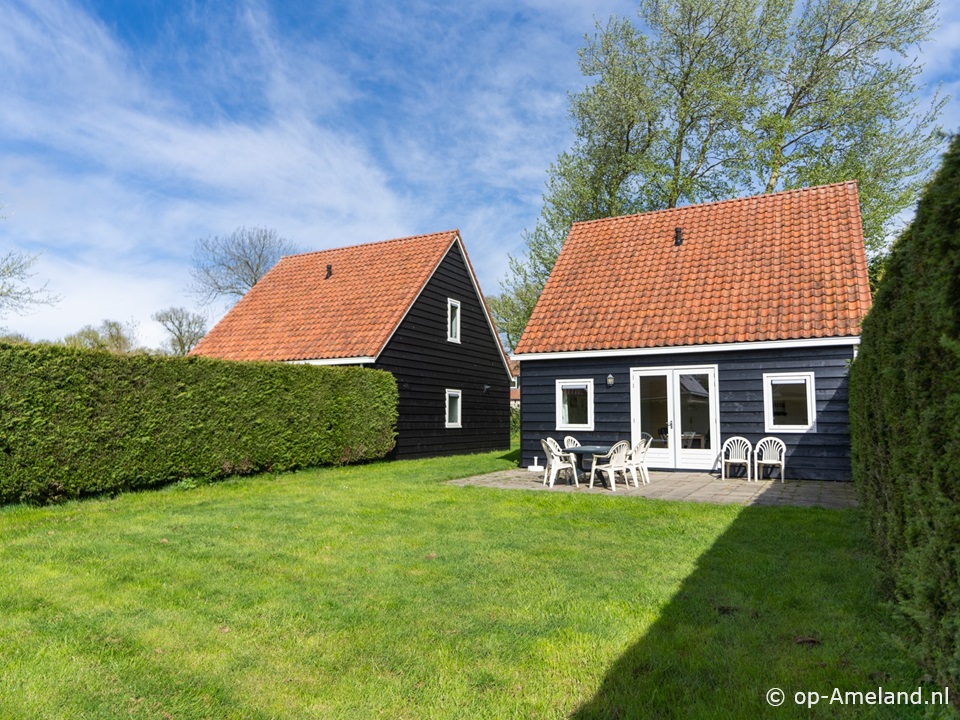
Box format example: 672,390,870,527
192,230,511,458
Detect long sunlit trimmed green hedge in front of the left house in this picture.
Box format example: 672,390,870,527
0,345,397,503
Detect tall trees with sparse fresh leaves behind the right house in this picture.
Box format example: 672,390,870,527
491,0,943,345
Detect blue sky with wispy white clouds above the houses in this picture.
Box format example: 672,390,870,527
0,0,960,346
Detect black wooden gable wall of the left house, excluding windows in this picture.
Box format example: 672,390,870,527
374,244,510,458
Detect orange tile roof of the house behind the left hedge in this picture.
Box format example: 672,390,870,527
190,230,469,360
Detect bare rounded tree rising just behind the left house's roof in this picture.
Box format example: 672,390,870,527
190,227,301,304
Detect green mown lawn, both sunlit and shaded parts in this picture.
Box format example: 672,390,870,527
0,453,952,720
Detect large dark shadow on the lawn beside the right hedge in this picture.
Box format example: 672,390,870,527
571,486,940,720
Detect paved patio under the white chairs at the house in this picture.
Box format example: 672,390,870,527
450,469,857,508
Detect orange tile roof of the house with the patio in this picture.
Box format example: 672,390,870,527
515,182,871,355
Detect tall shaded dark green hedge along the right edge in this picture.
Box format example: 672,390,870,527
850,132,960,688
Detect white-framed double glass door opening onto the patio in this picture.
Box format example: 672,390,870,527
630,366,720,470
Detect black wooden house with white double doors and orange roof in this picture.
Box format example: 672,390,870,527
514,182,871,480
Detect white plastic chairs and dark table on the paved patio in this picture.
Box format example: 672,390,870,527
540,433,786,492
